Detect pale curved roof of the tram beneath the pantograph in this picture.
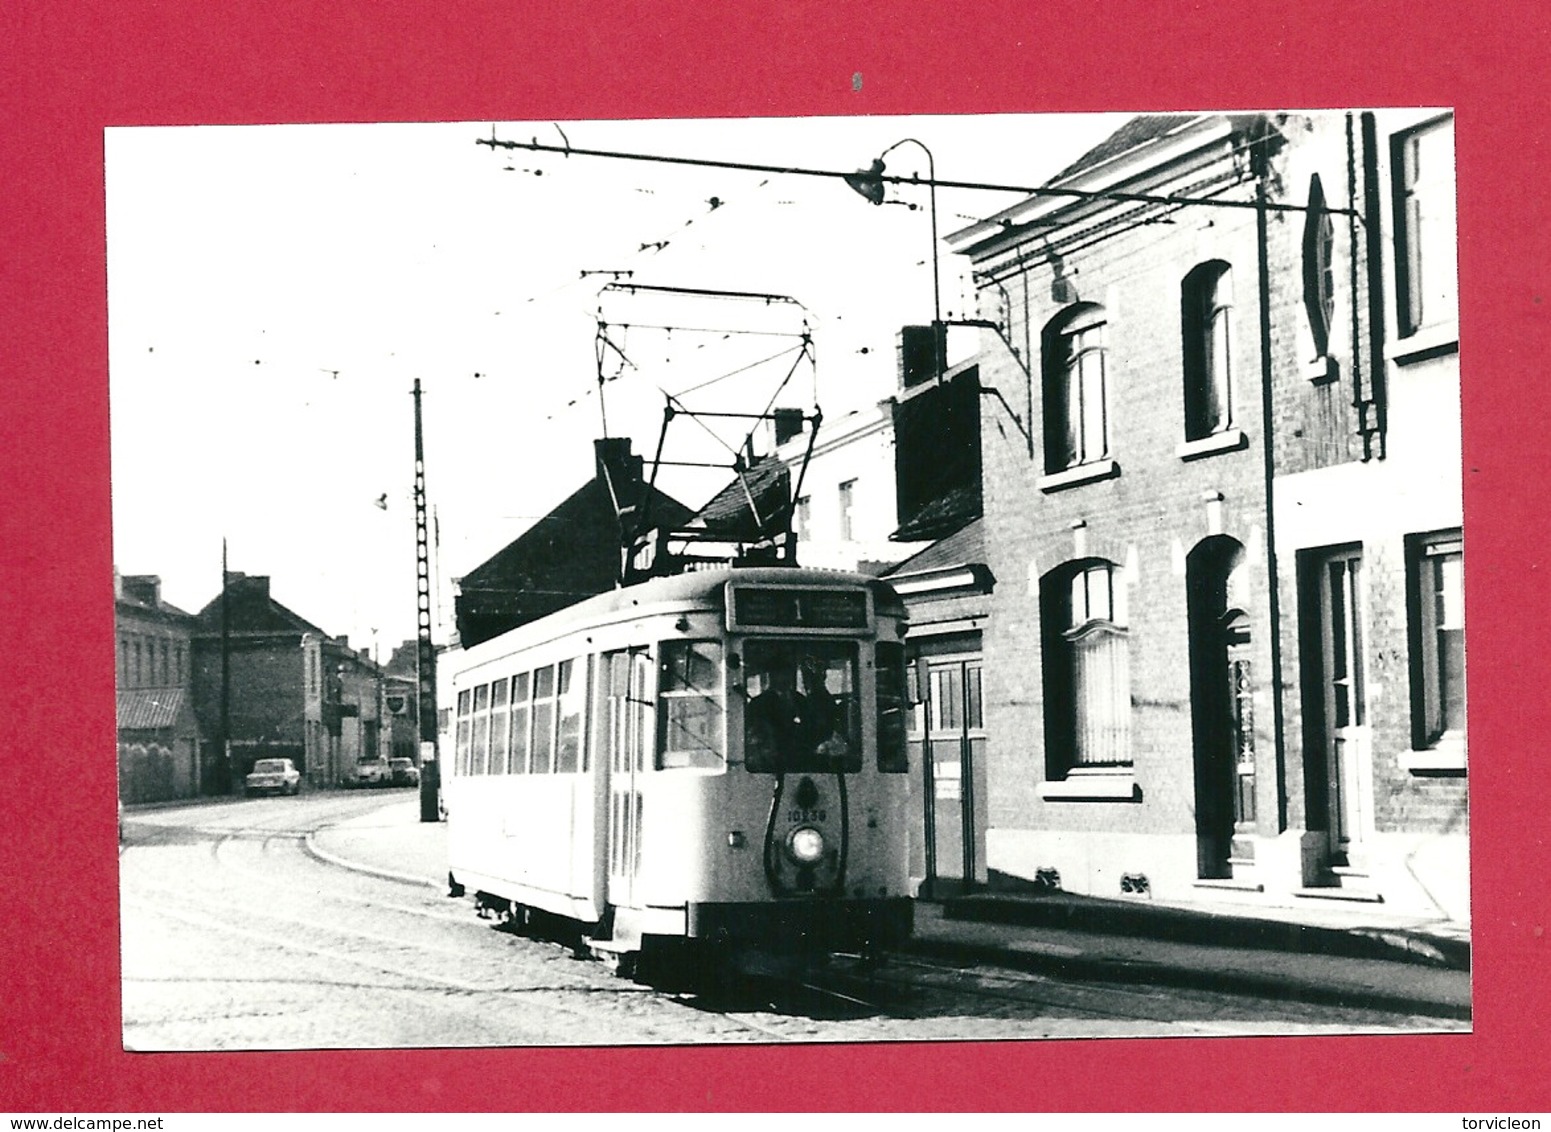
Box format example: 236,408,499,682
449,566,904,661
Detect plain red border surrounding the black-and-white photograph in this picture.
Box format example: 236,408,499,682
0,0,1551,1113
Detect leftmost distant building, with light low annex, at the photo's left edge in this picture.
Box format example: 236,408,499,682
113,571,203,802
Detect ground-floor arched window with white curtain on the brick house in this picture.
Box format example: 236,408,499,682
1041,560,1131,778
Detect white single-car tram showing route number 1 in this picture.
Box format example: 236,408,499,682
439,568,912,961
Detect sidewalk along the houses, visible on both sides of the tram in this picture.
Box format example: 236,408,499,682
307,802,1470,1020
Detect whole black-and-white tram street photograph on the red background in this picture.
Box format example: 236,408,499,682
109,107,1464,1053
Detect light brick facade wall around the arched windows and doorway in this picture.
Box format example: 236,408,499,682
982,119,1276,843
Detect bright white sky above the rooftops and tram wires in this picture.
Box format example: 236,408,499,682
105,115,1126,659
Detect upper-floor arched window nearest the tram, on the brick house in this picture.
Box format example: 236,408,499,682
1042,302,1109,473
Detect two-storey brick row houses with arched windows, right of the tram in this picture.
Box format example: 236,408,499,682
949,113,1466,915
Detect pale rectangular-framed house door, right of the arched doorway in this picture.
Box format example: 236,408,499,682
1306,547,1371,865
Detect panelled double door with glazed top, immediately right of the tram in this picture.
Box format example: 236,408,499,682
912,657,985,896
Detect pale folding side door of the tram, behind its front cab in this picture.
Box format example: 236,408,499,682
605,648,656,907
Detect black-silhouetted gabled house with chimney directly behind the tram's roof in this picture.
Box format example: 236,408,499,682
453,437,692,648
